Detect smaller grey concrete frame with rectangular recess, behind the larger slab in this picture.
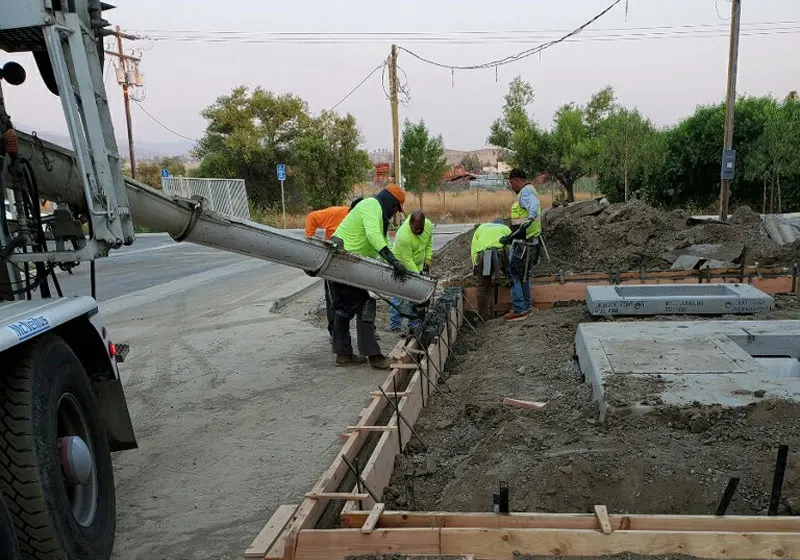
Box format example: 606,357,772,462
586,284,774,315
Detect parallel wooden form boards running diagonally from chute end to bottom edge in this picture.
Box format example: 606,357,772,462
253,300,464,560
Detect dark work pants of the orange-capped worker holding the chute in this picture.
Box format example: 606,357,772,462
328,282,381,357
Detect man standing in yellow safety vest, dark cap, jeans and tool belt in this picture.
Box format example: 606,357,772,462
501,168,542,321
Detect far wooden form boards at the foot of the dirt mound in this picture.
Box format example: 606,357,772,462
460,265,800,313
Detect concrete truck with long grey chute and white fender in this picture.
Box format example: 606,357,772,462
0,0,435,560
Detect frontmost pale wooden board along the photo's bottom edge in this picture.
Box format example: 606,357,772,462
295,527,800,560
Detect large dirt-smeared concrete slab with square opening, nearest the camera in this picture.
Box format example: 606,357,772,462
575,321,800,419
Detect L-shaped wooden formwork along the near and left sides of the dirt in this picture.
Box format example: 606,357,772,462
245,294,800,560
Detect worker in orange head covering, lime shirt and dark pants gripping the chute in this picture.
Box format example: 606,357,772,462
328,184,408,369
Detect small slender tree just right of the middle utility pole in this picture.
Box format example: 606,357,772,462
400,120,447,208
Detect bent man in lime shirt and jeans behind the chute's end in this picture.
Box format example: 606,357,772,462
389,210,433,333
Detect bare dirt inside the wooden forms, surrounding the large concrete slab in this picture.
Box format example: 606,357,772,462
384,296,800,514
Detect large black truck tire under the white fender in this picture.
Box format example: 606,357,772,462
0,333,116,560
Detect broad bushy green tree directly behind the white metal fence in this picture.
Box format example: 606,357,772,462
194,86,311,208
